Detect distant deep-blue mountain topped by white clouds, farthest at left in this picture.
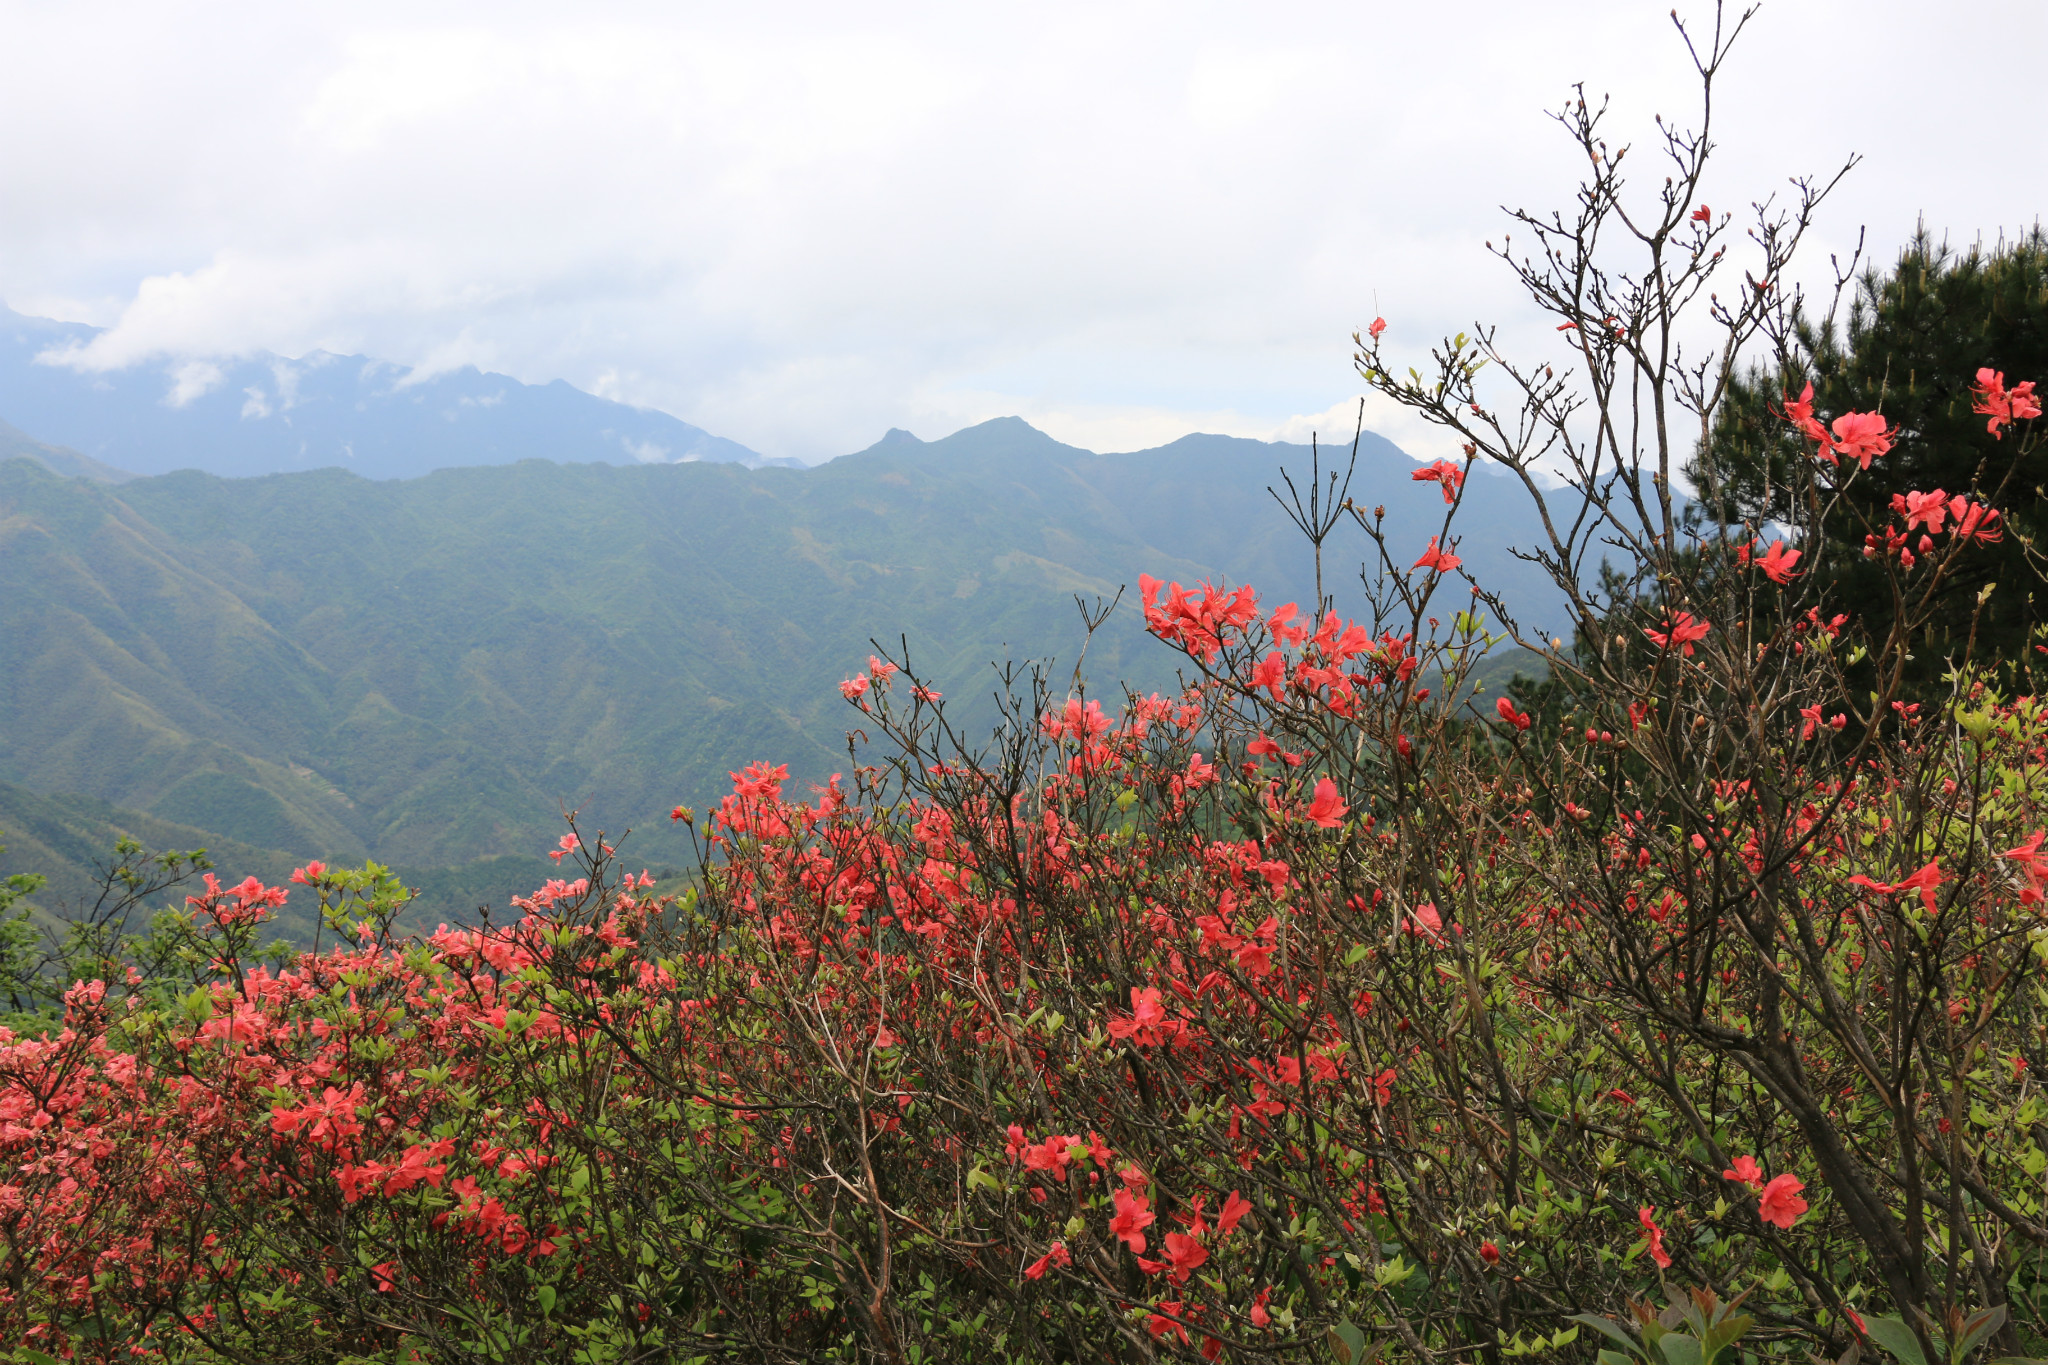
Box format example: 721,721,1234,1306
0,307,795,479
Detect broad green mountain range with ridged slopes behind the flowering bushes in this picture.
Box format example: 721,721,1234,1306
0,417,1550,896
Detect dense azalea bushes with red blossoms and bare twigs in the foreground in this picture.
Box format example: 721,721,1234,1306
0,10,2048,1365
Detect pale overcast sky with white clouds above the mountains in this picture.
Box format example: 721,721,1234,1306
0,0,2048,463
